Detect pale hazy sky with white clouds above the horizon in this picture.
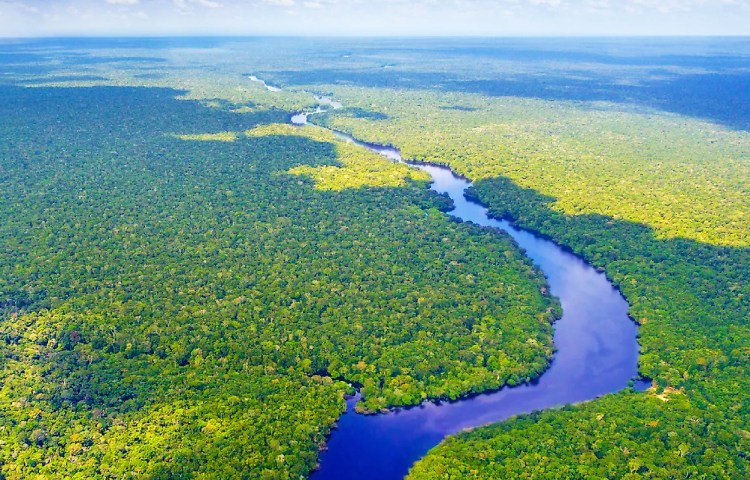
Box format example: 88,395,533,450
0,0,750,37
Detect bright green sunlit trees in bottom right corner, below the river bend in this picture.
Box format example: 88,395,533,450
409,393,748,479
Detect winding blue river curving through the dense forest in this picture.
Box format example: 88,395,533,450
291,97,648,480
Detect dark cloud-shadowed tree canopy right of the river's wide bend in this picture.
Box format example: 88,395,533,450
469,174,750,401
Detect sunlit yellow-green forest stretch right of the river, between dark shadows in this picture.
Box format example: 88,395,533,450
312,87,750,247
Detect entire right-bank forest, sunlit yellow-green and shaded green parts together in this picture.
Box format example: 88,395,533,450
310,85,750,478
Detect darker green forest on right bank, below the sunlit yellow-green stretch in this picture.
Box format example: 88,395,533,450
411,179,750,478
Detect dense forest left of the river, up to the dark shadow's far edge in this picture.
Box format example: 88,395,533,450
0,79,557,478
